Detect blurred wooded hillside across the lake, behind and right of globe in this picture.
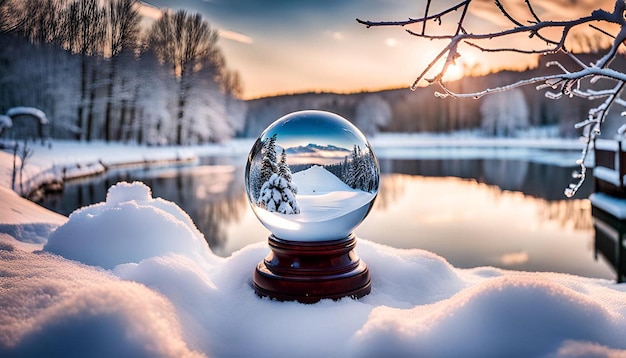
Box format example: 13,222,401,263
245,52,626,137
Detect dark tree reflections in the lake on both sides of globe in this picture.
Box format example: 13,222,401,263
42,158,593,258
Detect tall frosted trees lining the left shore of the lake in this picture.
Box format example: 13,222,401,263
0,0,245,144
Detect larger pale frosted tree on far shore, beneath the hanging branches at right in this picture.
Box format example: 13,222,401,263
480,88,529,137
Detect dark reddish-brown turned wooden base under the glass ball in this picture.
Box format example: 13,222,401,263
253,234,371,303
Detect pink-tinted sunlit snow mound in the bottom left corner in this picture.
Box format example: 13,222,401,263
0,249,201,357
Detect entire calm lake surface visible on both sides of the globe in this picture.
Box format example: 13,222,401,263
41,152,615,279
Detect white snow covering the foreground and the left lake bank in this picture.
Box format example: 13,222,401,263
0,136,626,357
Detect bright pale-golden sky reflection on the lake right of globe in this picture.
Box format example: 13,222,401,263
356,174,612,278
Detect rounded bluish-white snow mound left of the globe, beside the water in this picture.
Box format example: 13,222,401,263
44,182,215,269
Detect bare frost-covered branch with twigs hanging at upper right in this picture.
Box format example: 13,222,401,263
357,0,626,196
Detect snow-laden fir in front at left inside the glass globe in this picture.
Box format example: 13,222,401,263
257,173,300,215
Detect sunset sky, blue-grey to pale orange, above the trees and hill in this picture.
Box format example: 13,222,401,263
142,0,613,99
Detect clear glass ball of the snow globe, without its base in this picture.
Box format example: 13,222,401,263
245,111,380,241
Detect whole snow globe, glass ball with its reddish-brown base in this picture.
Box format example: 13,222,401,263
245,110,380,303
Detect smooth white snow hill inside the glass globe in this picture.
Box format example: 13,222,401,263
293,165,354,195
